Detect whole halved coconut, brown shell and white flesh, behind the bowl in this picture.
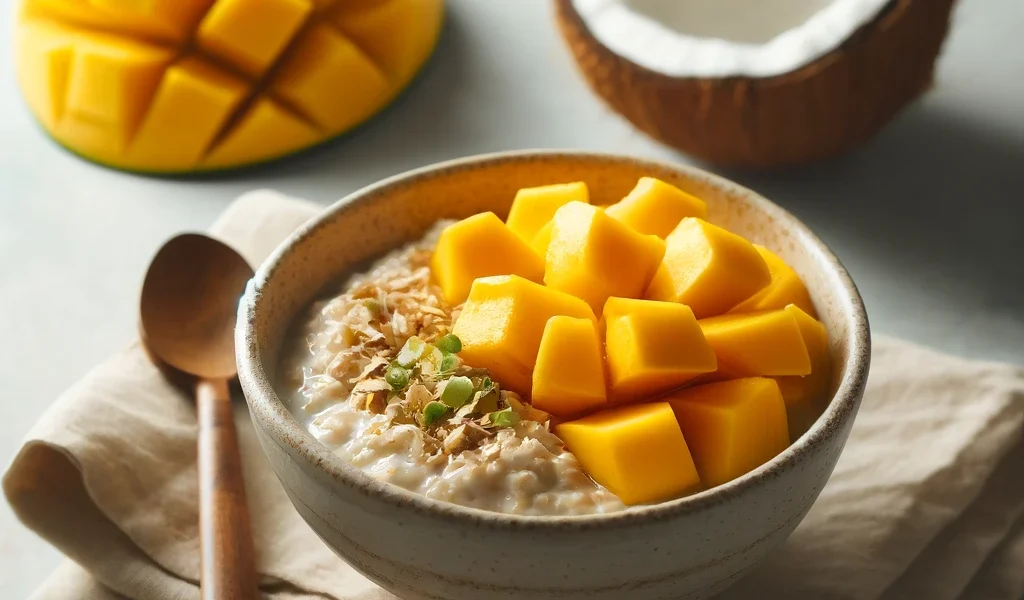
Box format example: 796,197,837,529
556,0,954,168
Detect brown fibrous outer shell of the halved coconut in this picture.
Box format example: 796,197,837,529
555,0,954,169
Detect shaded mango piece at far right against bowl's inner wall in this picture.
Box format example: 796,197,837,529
775,304,831,439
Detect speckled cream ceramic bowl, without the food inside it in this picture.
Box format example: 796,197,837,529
237,152,870,600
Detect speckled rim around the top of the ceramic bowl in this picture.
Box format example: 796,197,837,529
236,149,871,530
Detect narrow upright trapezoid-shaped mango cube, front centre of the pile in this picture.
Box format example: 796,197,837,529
530,315,607,418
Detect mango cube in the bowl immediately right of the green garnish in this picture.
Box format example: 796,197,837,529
452,274,597,395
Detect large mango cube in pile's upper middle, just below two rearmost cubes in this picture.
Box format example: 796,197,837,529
544,202,665,312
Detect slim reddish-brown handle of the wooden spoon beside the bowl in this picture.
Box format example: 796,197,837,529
196,380,258,600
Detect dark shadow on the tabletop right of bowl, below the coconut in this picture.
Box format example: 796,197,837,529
723,103,1024,317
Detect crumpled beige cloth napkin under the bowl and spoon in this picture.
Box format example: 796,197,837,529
3,190,1024,600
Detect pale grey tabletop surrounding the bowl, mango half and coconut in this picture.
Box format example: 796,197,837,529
0,0,1024,598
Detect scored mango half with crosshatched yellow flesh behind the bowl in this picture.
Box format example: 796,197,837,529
15,0,443,172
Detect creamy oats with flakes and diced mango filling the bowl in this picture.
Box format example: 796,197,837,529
275,177,829,515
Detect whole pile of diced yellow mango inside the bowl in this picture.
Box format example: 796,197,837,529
431,177,831,504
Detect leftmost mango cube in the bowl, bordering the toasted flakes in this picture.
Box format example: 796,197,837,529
430,212,544,306
